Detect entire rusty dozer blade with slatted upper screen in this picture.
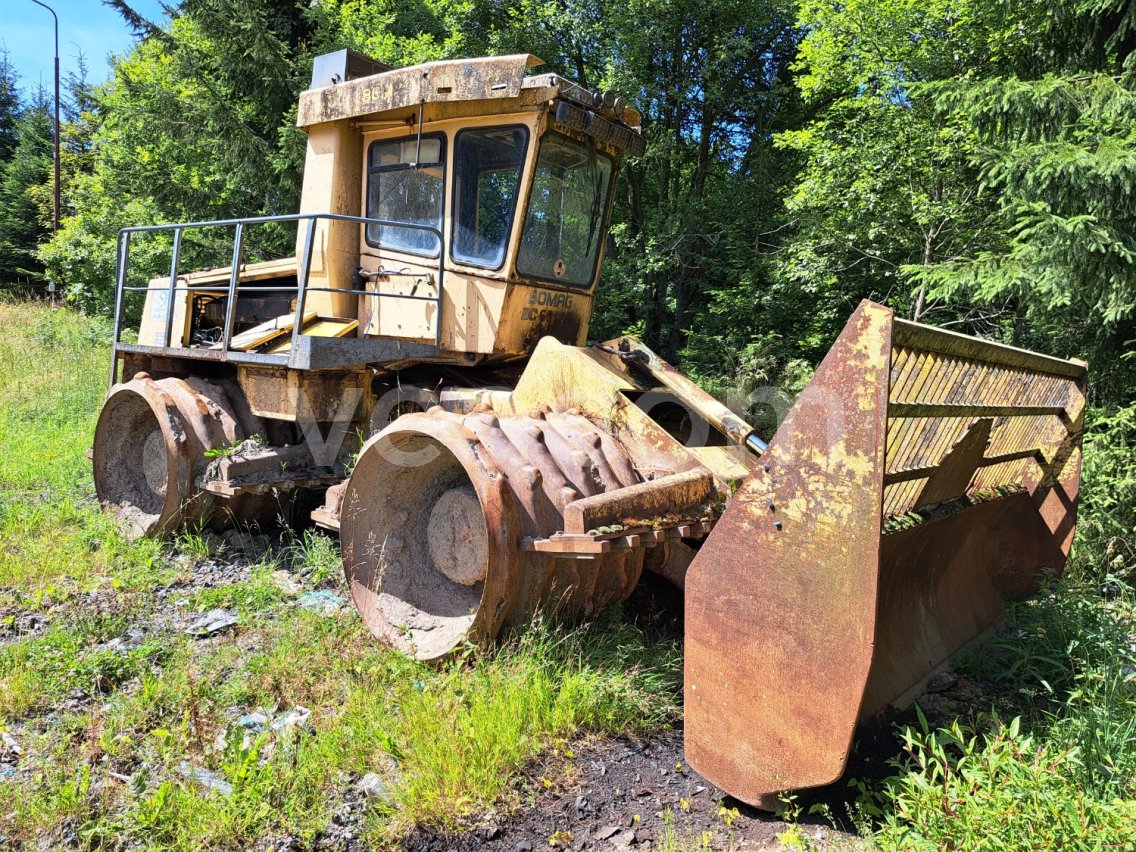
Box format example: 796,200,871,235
685,302,1086,808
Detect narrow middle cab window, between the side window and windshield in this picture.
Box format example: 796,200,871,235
450,127,528,269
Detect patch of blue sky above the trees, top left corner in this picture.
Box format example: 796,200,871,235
0,0,162,92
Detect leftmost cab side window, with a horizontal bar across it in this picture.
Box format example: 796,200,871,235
367,134,445,257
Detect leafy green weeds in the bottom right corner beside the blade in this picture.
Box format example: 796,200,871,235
863,573,1136,849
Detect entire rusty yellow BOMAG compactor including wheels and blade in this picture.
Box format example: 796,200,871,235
92,51,1086,804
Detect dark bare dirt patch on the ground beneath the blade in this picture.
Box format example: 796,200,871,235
402,575,996,852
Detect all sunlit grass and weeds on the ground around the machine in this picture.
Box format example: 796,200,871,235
0,302,1136,850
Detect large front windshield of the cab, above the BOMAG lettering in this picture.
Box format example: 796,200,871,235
517,132,612,286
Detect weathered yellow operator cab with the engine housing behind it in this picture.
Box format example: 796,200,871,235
132,51,644,368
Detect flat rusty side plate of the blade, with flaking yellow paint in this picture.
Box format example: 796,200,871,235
685,306,891,804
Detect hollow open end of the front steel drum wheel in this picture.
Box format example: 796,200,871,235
340,414,518,660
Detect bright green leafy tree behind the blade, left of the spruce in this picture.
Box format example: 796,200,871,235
778,0,1013,329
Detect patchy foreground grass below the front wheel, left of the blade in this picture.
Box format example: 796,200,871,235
0,610,676,849
